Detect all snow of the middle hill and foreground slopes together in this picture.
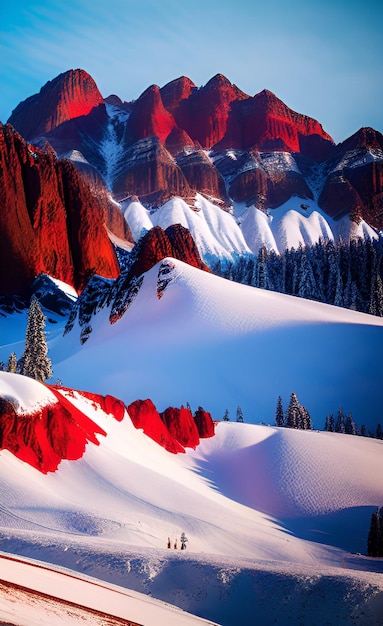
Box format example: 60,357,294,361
0,251,383,626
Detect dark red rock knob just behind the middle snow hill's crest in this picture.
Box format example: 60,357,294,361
129,224,210,278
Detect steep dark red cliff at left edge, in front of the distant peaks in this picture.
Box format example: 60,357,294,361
0,125,119,294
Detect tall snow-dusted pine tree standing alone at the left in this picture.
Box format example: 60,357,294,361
17,296,52,381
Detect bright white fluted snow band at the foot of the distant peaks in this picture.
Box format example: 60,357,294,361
124,191,378,263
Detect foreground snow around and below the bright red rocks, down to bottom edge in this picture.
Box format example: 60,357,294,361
0,372,383,626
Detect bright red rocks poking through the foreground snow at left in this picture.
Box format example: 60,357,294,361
0,374,214,474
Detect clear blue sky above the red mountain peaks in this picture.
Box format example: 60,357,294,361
0,0,383,142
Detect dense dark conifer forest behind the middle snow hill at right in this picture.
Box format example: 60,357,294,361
212,238,383,317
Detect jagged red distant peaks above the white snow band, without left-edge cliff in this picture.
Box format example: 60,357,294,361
9,70,383,229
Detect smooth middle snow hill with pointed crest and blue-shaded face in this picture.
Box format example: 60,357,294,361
50,260,383,428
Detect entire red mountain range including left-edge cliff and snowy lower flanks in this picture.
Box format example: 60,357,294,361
0,70,383,294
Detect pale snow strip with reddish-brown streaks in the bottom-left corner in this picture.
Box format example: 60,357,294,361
0,554,213,626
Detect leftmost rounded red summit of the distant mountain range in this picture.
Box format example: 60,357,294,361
8,69,103,141
